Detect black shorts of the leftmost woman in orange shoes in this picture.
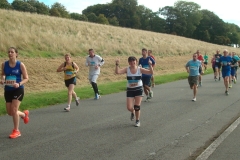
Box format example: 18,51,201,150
4,88,24,103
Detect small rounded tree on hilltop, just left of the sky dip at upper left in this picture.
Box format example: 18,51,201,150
49,2,70,18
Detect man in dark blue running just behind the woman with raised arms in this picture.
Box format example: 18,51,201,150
138,48,155,101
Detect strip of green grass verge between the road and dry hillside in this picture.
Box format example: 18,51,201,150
0,69,213,115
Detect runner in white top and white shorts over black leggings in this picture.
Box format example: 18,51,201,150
86,49,104,100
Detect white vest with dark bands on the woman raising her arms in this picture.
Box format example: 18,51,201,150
127,67,142,89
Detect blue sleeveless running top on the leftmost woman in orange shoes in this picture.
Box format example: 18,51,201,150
4,61,24,91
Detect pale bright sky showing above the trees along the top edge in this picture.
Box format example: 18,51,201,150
8,0,240,27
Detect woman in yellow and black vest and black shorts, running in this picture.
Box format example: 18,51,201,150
57,53,80,111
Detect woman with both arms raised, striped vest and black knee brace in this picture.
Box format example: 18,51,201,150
115,57,153,127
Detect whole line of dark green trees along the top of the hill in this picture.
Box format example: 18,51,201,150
0,0,240,45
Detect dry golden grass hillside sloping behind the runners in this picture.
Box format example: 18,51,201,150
0,10,239,95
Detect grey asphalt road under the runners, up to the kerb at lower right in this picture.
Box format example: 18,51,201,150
0,75,240,160
